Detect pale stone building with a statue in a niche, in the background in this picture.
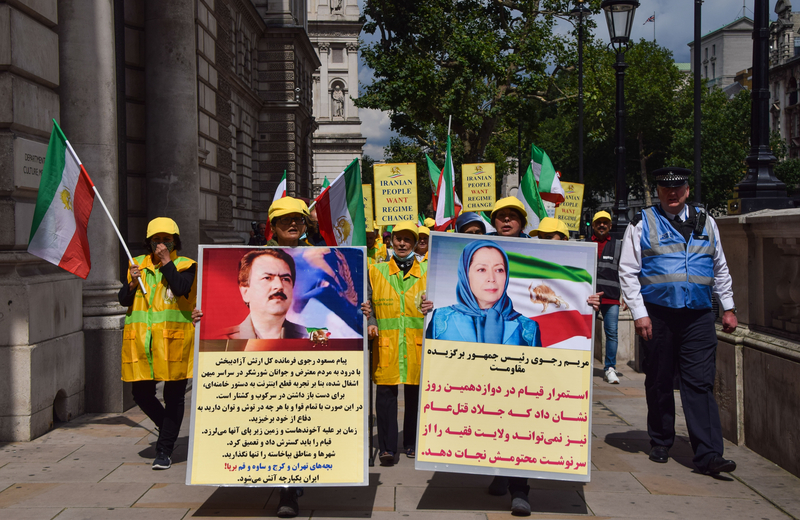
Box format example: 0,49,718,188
308,0,367,195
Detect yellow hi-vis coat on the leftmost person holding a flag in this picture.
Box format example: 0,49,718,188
122,251,197,381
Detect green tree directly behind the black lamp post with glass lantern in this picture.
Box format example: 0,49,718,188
534,40,683,205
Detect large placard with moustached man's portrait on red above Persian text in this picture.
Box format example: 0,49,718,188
186,246,368,486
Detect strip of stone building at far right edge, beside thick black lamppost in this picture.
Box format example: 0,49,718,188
769,0,800,158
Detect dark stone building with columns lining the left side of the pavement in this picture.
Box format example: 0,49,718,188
0,0,320,440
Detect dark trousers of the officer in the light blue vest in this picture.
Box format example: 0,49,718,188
644,304,723,471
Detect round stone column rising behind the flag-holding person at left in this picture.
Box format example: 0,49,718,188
142,0,200,259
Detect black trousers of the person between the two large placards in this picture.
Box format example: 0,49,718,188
375,385,419,453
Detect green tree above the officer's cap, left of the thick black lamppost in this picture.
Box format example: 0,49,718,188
668,81,750,214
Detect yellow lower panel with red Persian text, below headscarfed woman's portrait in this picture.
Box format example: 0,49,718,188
417,339,592,481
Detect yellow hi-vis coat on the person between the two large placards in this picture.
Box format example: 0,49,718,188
369,258,428,385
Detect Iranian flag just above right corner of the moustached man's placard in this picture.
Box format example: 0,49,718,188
316,159,367,246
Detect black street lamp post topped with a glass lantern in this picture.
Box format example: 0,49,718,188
600,0,639,237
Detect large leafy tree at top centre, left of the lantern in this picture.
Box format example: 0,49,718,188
356,0,584,163
